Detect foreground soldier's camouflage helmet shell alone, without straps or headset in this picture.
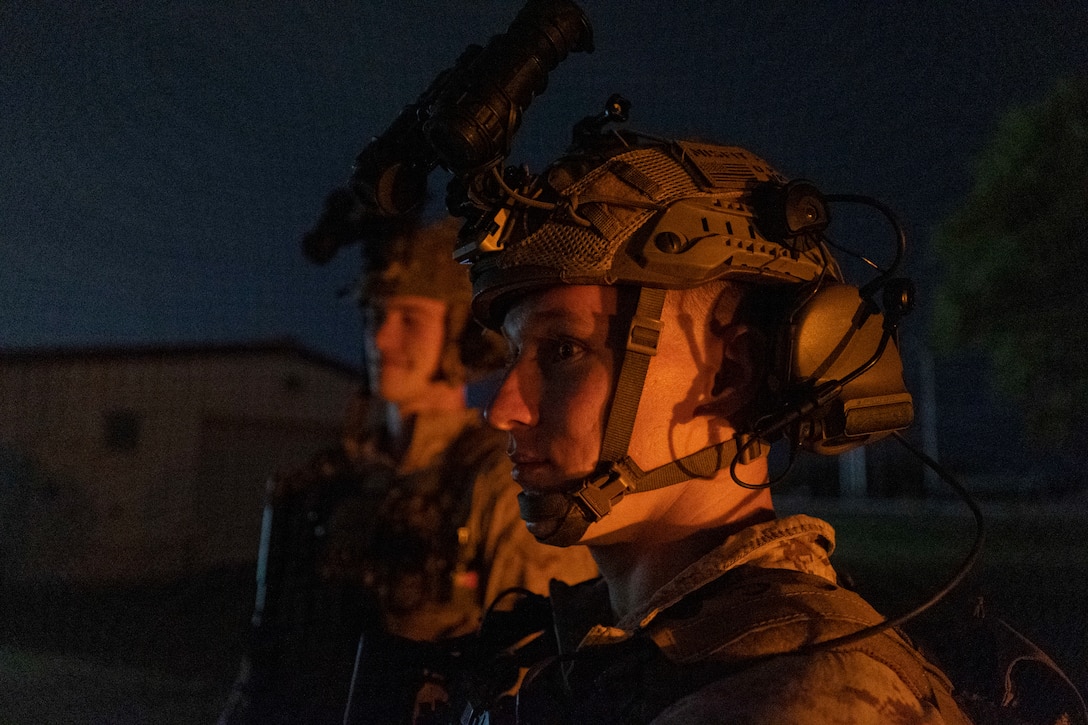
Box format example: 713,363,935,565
472,142,840,327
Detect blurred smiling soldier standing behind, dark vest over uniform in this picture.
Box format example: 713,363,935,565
221,215,596,725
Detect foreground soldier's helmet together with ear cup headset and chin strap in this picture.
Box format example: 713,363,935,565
457,127,913,545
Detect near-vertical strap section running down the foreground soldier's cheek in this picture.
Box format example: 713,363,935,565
601,287,665,464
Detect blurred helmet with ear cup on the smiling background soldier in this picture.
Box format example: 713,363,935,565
356,217,504,384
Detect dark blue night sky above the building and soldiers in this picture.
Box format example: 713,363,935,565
0,0,1088,372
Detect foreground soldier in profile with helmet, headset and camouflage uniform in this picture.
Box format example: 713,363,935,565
443,134,979,725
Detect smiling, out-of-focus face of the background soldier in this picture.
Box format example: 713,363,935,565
364,295,447,413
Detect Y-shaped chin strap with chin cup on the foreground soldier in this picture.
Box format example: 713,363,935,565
518,287,764,546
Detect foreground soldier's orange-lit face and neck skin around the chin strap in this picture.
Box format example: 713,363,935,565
486,285,743,543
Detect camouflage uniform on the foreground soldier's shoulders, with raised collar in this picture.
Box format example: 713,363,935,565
476,515,968,725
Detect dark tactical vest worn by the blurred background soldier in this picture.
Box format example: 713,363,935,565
224,418,503,725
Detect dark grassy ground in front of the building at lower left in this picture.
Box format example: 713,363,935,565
0,570,254,725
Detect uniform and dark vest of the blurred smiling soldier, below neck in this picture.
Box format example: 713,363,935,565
221,409,596,725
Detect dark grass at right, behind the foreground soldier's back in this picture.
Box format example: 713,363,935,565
809,500,1088,692
